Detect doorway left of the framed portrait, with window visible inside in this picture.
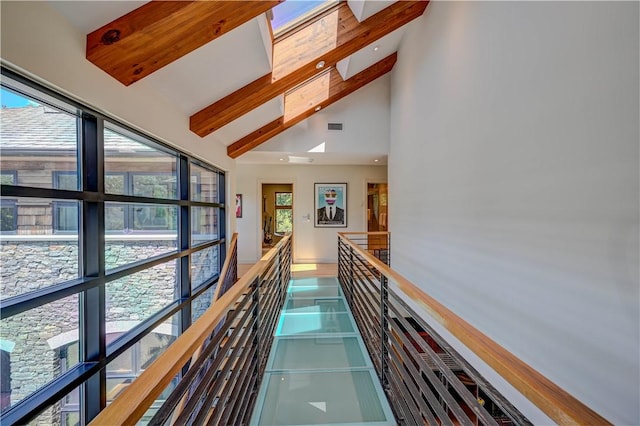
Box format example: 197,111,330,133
261,183,293,254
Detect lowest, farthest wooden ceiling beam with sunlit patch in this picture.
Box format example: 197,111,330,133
227,53,398,158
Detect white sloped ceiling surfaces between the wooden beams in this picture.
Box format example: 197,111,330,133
51,0,426,164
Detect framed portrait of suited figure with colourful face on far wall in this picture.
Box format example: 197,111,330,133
314,183,347,228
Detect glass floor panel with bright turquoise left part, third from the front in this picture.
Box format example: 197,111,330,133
276,312,355,336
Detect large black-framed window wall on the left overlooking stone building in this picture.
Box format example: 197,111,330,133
0,69,226,425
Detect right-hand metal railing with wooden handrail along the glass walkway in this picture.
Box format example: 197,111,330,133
338,233,608,425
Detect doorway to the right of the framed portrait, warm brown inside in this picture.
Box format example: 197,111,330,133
367,183,389,258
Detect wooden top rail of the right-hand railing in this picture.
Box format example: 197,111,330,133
338,232,611,425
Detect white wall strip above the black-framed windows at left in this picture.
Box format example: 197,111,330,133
0,1,235,170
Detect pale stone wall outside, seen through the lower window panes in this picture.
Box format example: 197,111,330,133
0,240,218,424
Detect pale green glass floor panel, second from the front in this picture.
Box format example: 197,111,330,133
268,336,370,370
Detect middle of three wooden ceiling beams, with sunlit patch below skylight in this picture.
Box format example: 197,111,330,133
190,0,428,137
